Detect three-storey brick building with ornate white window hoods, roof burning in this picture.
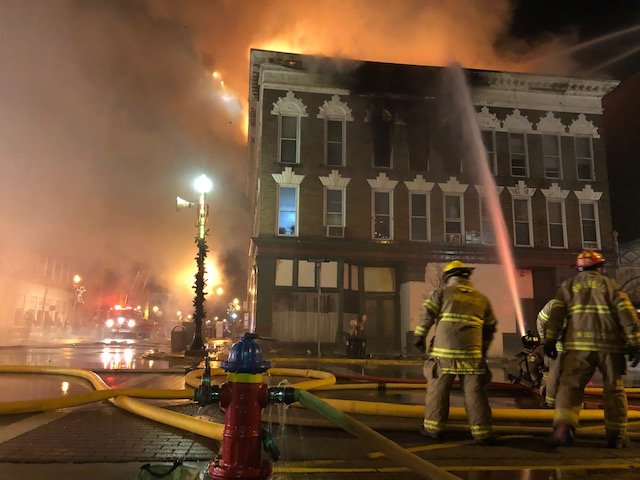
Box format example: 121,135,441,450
249,50,617,355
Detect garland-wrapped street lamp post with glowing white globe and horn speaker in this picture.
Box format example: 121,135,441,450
178,174,212,355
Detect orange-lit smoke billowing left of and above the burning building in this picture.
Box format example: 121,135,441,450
0,0,592,308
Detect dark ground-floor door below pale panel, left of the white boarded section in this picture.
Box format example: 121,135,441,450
364,295,400,354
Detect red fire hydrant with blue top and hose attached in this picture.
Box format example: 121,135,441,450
193,333,295,480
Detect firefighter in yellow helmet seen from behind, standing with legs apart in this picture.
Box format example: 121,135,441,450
415,260,496,445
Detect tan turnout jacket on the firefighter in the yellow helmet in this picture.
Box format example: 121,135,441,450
414,277,496,374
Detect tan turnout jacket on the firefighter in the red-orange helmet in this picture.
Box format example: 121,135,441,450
544,270,640,353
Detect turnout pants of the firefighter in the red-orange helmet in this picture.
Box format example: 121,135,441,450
553,350,627,436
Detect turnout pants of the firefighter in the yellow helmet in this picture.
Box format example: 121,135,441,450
424,358,493,440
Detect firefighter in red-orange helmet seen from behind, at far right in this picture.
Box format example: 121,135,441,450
544,250,640,448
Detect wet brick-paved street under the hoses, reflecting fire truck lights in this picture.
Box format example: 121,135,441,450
0,338,640,480
